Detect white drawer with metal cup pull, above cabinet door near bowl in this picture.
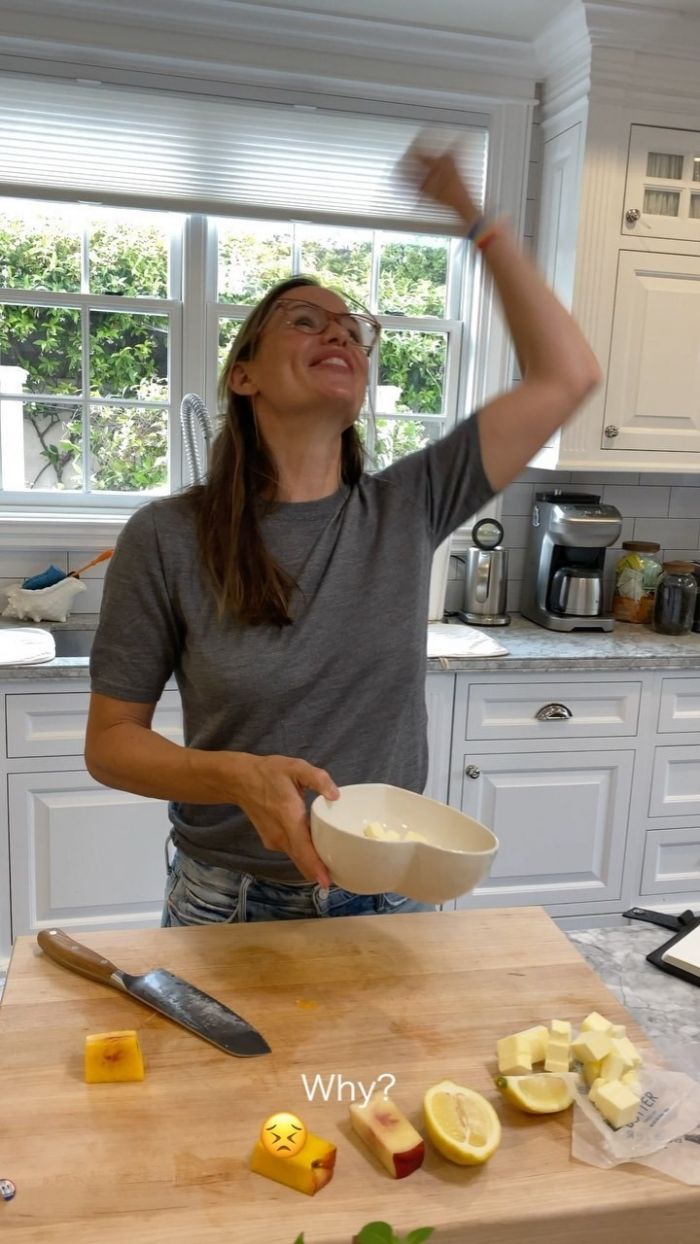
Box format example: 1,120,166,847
465,680,642,741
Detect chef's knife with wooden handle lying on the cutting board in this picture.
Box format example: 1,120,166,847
36,929,270,1059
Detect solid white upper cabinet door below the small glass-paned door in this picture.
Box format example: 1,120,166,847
602,250,700,462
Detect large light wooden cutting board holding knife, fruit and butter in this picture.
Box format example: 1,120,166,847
0,908,700,1244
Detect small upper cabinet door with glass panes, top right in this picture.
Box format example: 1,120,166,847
622,126,700,241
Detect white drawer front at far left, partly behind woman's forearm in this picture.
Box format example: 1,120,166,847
5,690,183,759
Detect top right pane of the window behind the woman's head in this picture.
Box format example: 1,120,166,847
378,234,448,316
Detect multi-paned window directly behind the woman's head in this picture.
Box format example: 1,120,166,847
215,219,465,469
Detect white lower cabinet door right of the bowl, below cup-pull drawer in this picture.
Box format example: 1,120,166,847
453,749,634,907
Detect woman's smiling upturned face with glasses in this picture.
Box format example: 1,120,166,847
230,285,369,427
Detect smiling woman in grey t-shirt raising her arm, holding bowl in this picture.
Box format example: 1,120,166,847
86,152,599,924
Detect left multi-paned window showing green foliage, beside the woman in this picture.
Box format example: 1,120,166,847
0,199,182,505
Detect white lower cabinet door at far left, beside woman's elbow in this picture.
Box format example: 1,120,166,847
7,768,169,937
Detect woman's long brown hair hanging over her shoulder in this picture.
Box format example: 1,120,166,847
190,284,364,626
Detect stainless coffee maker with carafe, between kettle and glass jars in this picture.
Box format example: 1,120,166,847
520,489,622,631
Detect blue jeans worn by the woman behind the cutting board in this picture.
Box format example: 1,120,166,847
160,851,435,928
